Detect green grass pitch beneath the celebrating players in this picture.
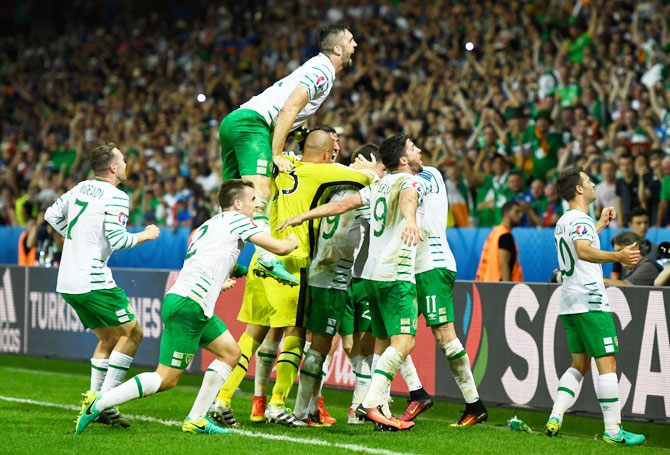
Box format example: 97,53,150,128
0,355,670,455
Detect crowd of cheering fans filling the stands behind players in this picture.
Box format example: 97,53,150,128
0,0,670,274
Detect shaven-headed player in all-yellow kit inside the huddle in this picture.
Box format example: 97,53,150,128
210,131,371,426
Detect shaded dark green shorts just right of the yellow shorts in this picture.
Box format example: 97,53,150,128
306,286,349,335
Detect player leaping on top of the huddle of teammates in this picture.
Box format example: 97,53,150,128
219,24,356,285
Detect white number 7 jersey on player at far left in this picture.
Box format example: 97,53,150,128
44,179,137,294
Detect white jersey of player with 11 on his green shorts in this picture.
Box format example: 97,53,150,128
416,166,456,273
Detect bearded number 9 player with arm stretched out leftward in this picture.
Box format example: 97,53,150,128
280,134,426,431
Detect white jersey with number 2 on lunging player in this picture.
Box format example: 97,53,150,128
168,210,263,318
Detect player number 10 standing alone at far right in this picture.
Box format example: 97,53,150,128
543,168,645,445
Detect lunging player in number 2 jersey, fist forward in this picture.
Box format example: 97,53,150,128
76,180,298,434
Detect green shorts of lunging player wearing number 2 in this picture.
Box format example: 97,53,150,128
159,294,228,370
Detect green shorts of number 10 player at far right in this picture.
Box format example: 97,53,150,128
560,311,619,357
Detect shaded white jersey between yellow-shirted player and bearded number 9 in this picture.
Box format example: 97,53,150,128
307,189,364,291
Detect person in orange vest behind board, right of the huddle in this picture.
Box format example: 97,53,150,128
475,201,523,281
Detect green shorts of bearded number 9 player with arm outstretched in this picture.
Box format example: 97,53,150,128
365,280,419,337
